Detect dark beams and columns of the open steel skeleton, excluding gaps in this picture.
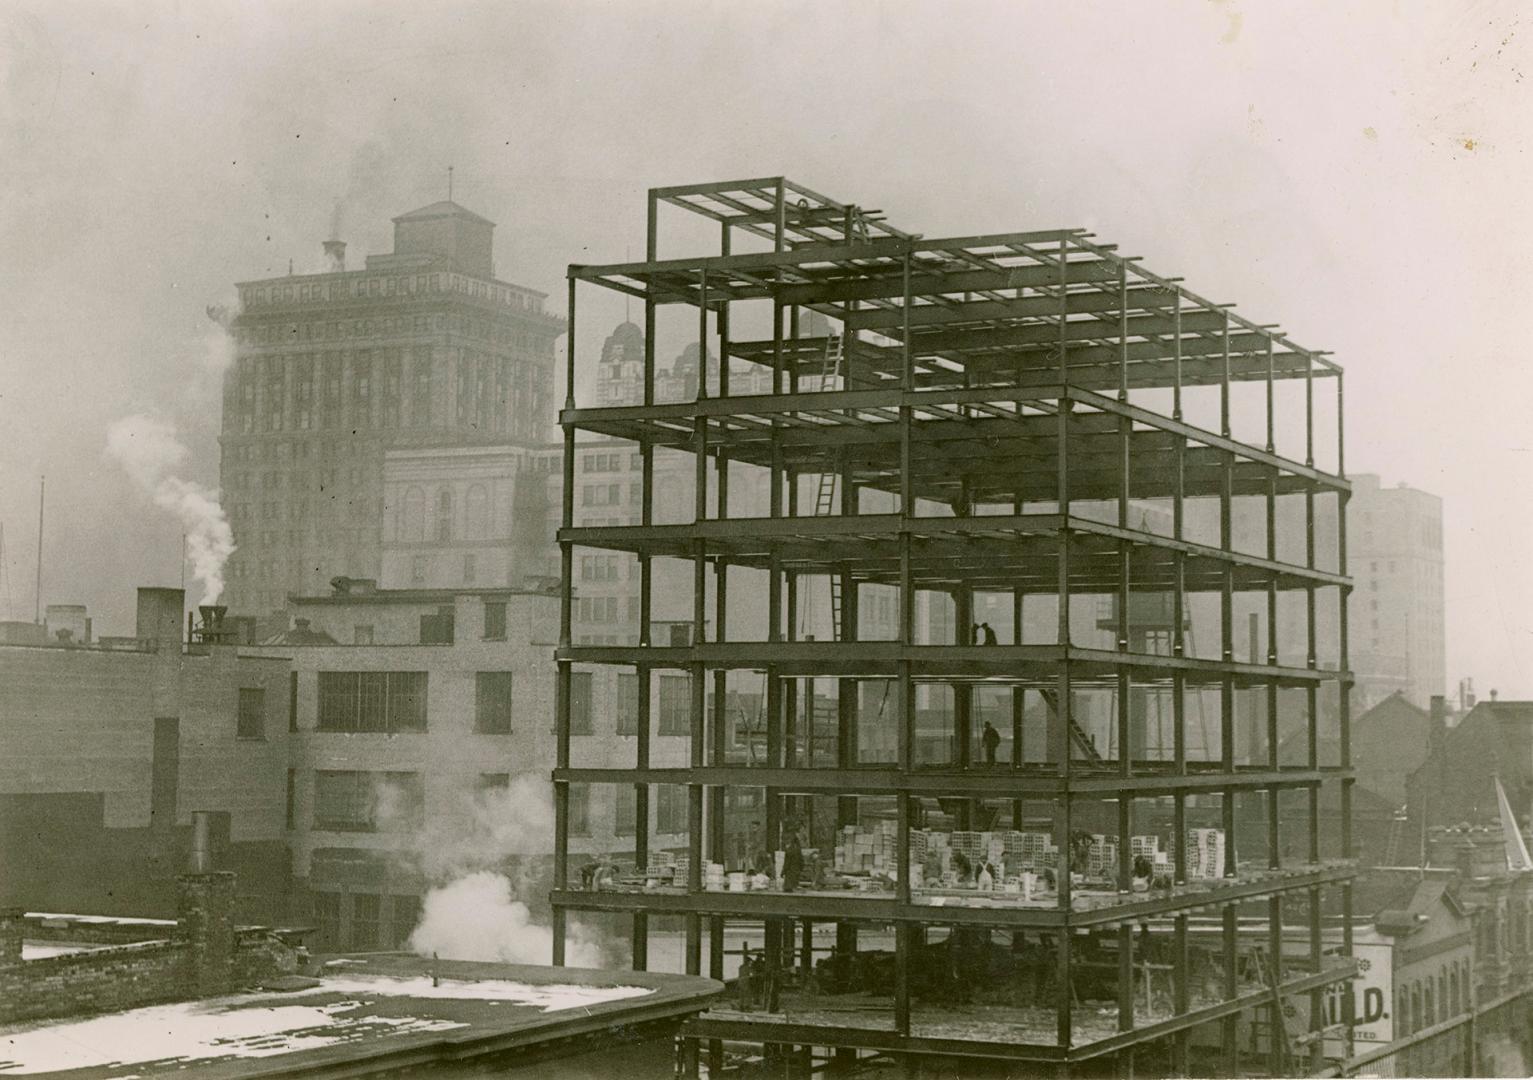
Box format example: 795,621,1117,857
552,178,1352,1068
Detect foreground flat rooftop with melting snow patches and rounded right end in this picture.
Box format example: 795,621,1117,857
0,953,724,1080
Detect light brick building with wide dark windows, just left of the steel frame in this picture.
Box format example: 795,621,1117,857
246,579,685,950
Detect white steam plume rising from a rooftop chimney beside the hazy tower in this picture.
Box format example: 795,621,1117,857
106,414,235,604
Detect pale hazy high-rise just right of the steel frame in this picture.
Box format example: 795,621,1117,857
1348,473,1447,709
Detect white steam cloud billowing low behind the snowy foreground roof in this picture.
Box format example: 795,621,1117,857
374,775,604,968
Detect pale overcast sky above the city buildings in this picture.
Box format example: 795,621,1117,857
0,0,1533,697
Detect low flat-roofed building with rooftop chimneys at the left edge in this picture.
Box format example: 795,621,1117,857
0,588,288,922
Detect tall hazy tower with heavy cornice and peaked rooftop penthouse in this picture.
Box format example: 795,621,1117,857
221,201,564,614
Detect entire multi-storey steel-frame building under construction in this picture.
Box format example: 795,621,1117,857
552,178,1355,1075
